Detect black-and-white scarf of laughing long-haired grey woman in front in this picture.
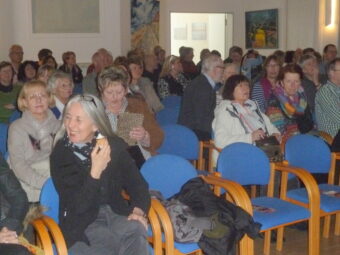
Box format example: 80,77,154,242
63,133,97,166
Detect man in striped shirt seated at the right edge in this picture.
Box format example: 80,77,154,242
315,58,340,137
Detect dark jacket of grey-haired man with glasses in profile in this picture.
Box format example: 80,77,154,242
178,74,216,140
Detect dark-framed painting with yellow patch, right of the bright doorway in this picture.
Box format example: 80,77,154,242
246,9,279,49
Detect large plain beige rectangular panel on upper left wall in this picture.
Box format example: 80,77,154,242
32,0,100,34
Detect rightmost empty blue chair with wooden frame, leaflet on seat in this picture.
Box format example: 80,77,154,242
285,135,340,238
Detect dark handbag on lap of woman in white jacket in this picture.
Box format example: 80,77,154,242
255,136,283,162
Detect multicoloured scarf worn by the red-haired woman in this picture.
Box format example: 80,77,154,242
274,86,307,118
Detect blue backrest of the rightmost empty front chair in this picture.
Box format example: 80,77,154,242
285,135,331,173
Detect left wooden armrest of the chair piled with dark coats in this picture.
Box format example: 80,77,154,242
151,198,175,254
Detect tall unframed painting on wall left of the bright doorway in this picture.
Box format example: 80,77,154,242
131,0,159,52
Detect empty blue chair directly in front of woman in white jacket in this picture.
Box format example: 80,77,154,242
217,143,320,255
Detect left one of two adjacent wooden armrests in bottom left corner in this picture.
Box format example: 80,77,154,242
31,218,54,255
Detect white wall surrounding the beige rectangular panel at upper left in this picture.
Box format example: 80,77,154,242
0,0,127,63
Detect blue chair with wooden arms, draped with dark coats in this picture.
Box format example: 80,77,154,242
141,154,253,255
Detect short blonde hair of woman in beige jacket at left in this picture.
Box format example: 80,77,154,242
18,80,55,112
